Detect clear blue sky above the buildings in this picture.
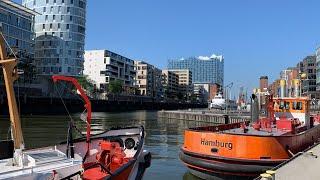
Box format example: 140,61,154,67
17,0,320,95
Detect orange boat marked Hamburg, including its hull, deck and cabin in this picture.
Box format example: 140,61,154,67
180,93,320,179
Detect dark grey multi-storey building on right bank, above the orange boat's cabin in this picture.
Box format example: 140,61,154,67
297,55,320,99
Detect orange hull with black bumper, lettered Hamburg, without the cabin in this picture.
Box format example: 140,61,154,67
180,125,320,176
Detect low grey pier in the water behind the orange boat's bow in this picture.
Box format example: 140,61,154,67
158,110,250,124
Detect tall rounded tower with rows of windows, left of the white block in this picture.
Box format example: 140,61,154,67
23,0,86,76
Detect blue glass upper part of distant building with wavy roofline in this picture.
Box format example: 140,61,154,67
168,55,224,85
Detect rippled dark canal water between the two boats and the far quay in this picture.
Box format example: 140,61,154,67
0,111,212,180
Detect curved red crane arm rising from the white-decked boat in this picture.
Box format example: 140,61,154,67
52,75,91,151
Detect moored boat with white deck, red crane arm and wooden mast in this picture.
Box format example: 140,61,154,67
0,32,151,180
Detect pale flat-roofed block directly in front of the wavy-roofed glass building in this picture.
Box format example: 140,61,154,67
169,69,193,99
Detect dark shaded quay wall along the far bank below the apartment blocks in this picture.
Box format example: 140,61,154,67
0,97,206,115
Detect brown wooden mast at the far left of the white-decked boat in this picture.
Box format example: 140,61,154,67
0,32,24,149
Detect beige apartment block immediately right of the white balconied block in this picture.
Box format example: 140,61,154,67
134,61,163,98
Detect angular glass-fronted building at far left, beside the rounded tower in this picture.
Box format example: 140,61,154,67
0,0,36,84
